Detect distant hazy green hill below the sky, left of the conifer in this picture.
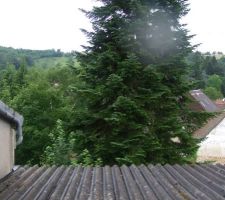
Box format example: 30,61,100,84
0,46,72,69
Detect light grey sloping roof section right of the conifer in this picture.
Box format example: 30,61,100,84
190,89,219,112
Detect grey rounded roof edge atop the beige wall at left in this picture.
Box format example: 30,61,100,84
0,101,24,145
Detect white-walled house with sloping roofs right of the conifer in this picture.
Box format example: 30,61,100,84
190,90,225,163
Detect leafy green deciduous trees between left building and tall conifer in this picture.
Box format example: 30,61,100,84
0,61,76,164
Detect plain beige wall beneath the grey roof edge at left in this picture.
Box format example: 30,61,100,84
0,119,16,178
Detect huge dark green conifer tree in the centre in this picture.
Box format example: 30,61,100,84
75,0,197,164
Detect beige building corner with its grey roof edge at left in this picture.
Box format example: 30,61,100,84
0,101,23,179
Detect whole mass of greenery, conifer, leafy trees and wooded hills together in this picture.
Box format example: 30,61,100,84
0,0,217,165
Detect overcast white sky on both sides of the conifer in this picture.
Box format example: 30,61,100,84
0,0,225,53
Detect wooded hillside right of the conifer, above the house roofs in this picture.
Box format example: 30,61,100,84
187,52,225,100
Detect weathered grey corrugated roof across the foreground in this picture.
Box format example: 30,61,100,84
0,164,225,200
